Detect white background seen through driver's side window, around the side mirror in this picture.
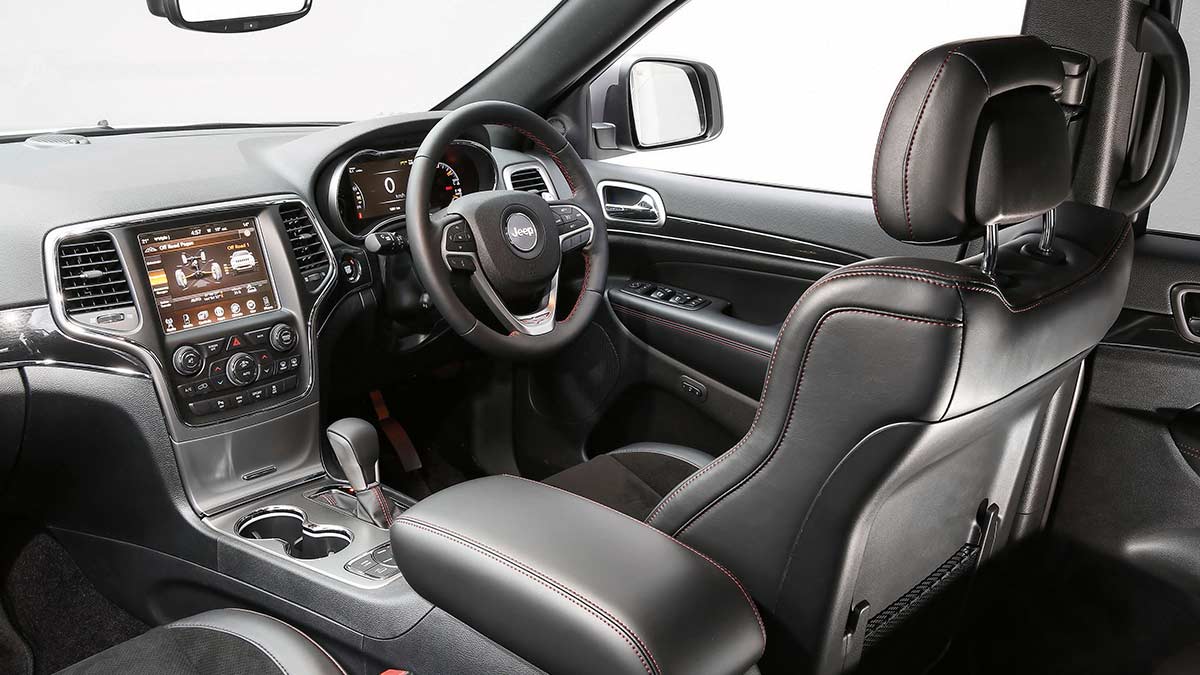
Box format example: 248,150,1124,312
610,0,1025,195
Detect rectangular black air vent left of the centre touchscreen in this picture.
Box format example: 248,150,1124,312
59,234,133,315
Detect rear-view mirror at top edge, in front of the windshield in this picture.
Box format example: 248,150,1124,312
146,0,312,32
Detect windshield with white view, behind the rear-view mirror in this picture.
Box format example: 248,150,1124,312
0,0,557,135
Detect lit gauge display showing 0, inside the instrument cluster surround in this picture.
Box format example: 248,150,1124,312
346,150,463,221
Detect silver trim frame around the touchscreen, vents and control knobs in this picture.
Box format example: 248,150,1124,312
42,193,337,437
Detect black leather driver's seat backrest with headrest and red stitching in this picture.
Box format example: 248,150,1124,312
648,36,1133,671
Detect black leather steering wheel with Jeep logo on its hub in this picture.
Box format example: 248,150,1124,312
404,101,608,359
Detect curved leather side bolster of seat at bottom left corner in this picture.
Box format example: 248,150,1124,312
164,609,346,675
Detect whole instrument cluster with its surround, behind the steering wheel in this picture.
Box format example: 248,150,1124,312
330,139,498,238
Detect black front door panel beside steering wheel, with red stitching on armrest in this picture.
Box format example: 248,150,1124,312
515,161,961,476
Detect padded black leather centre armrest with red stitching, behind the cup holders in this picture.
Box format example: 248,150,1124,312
391,477,766,675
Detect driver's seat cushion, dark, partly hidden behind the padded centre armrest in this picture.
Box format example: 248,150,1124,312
545,443,713,520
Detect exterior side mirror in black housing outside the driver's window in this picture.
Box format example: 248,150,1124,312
592,56,725,153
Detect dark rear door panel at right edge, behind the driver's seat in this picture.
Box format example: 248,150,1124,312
1052,228,1200,602
